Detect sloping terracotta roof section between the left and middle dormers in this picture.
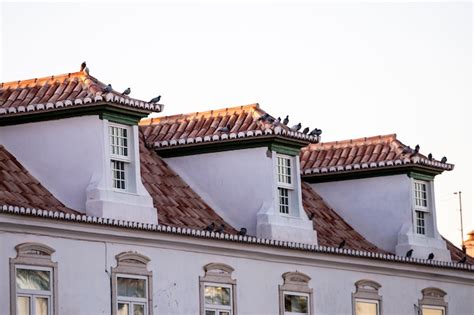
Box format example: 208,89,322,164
140,137,236,234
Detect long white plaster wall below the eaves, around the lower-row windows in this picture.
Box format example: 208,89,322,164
0,228,474,315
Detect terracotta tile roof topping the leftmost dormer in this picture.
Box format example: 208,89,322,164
0,71,163,117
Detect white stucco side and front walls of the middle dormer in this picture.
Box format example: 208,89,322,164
165,147,317,243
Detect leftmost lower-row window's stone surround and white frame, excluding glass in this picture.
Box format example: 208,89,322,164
10,242,58,315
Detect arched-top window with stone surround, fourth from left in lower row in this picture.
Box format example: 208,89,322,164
278,272,313,315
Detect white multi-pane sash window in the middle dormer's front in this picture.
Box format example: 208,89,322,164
277,155,294,215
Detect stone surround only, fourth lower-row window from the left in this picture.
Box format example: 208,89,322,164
278,271,314,315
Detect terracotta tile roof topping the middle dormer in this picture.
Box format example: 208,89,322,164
140,104,318,148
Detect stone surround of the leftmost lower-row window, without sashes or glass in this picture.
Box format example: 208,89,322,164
10,242,59,315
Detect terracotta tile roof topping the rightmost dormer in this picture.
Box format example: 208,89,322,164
300,134,454,176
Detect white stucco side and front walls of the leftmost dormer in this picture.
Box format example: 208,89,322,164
0,116,157,223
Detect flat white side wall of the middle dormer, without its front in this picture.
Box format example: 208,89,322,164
165,147,275,235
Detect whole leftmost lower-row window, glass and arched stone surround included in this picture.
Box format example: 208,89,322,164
10,243,58,315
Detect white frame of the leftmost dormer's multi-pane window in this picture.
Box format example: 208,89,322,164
107,122,133,192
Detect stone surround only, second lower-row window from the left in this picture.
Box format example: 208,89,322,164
111,251,153,315
